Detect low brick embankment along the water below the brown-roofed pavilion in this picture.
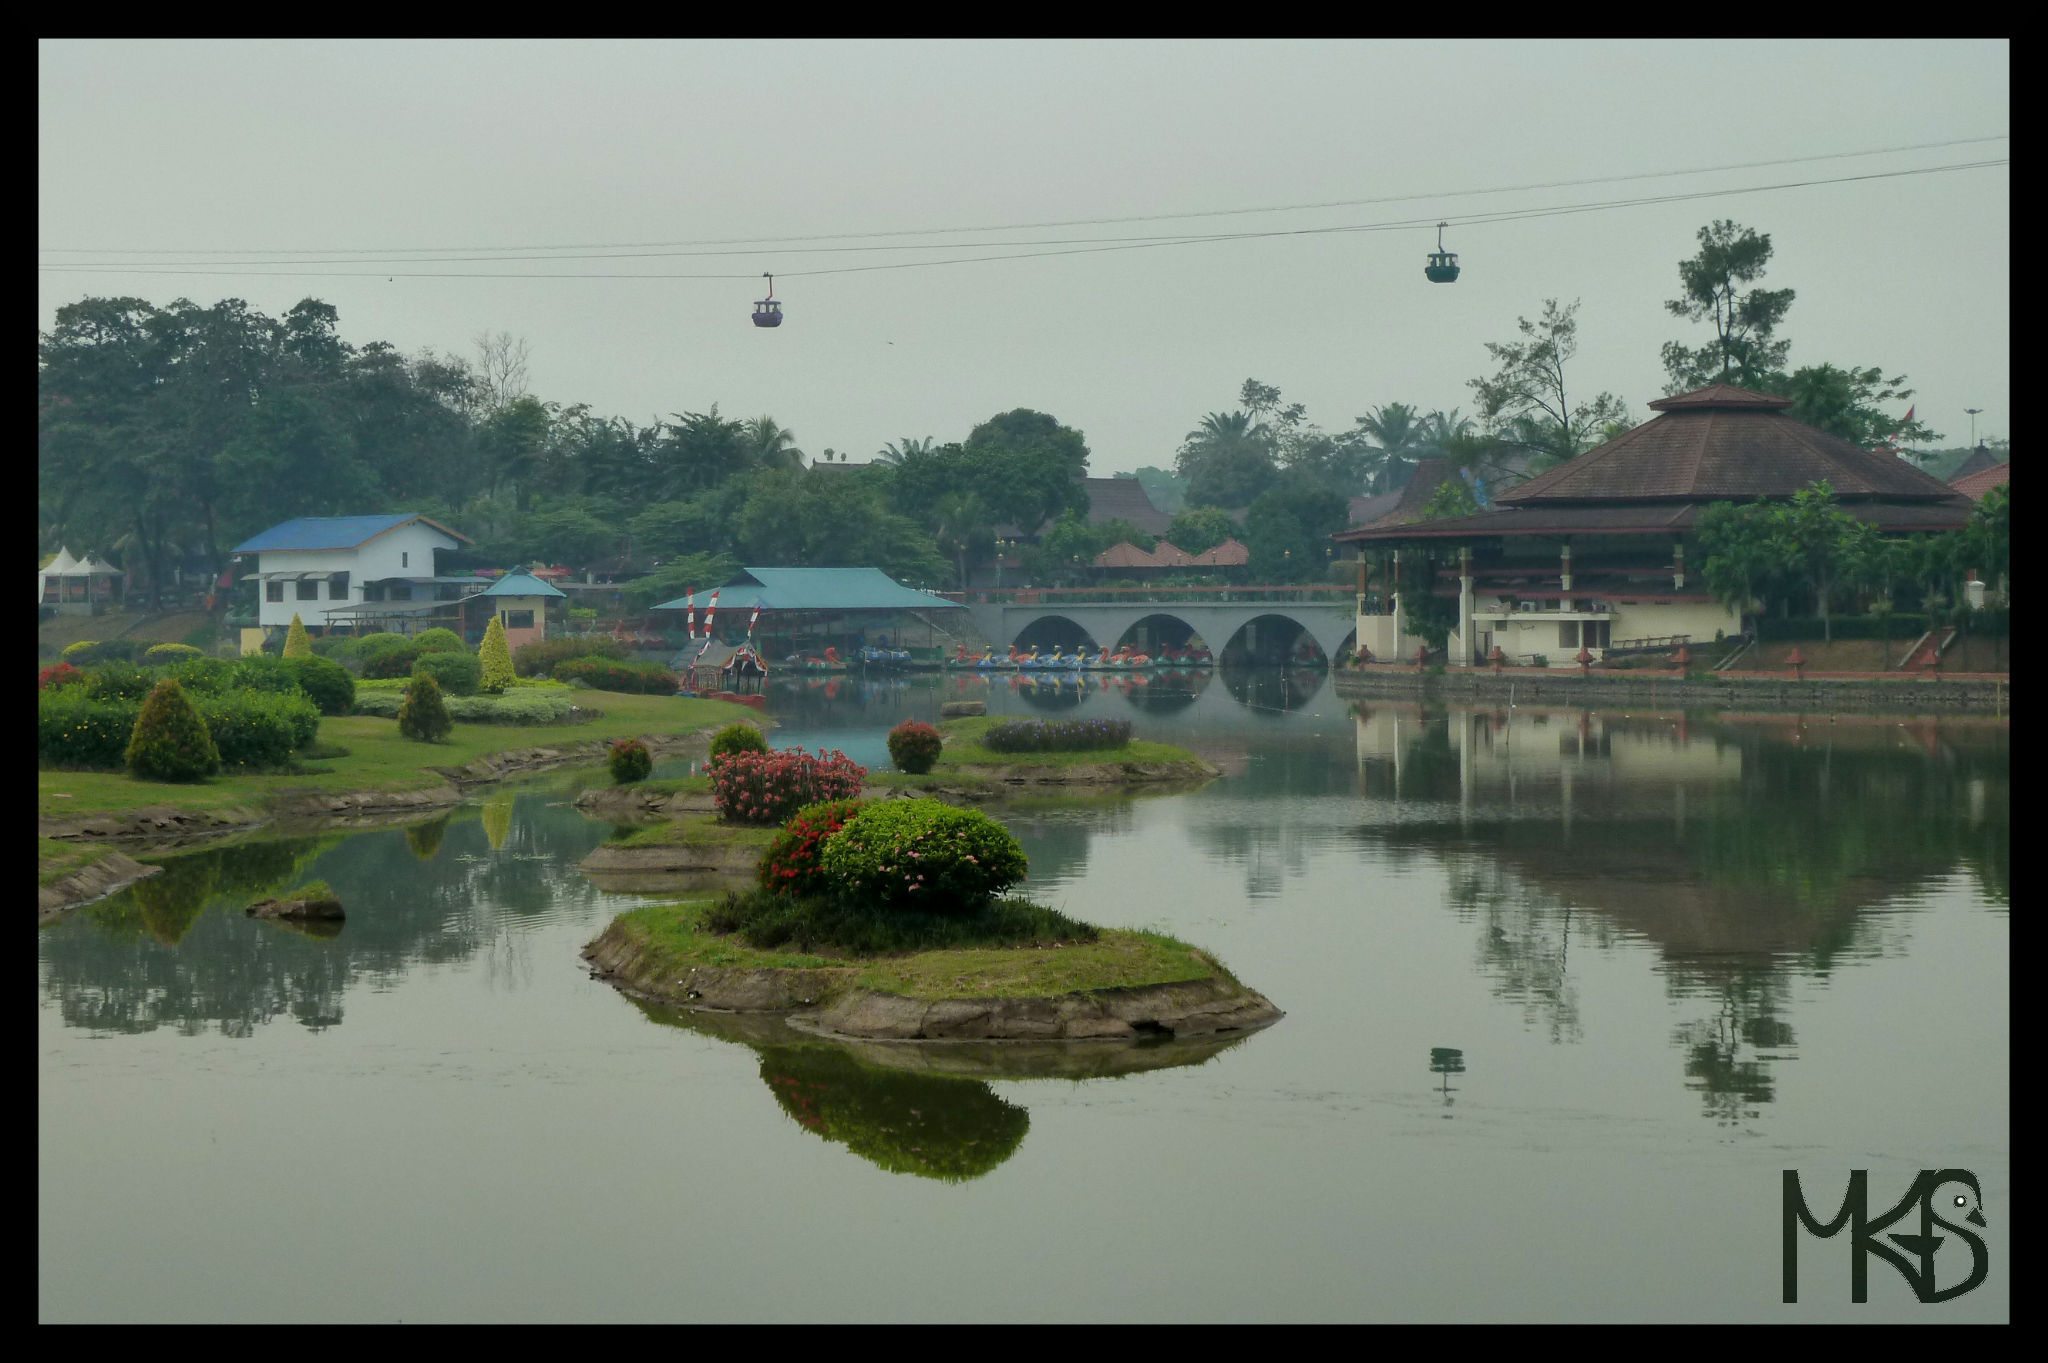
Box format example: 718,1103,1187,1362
1333,665,2013,714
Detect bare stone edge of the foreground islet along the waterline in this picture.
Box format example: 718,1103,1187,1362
584,921,1282,1042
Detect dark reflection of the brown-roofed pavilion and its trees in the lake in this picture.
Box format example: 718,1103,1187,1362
1356,706,2011,1122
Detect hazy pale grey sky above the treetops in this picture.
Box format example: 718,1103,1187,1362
37,39,2011,475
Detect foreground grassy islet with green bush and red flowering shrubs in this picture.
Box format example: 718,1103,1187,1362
586,753,1280,1042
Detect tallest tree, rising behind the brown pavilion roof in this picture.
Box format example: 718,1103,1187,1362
1663,219,1794,393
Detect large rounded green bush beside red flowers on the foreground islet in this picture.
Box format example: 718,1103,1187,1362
819,800,1026,913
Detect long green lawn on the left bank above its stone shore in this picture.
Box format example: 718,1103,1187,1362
37,692,754,819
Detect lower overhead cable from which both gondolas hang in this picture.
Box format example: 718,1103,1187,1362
37,158,2011,280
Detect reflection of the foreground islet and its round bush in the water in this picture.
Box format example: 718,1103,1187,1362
627,995,1245,1183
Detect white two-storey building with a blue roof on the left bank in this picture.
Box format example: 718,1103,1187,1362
231,512,485,634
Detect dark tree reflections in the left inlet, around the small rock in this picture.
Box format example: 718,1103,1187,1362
37,794,604,1036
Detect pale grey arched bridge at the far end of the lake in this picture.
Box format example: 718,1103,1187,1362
965,587,1358,659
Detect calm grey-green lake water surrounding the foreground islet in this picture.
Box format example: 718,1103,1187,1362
37,671,2011,1320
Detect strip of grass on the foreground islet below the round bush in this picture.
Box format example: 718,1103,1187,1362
618,900,1235,999
